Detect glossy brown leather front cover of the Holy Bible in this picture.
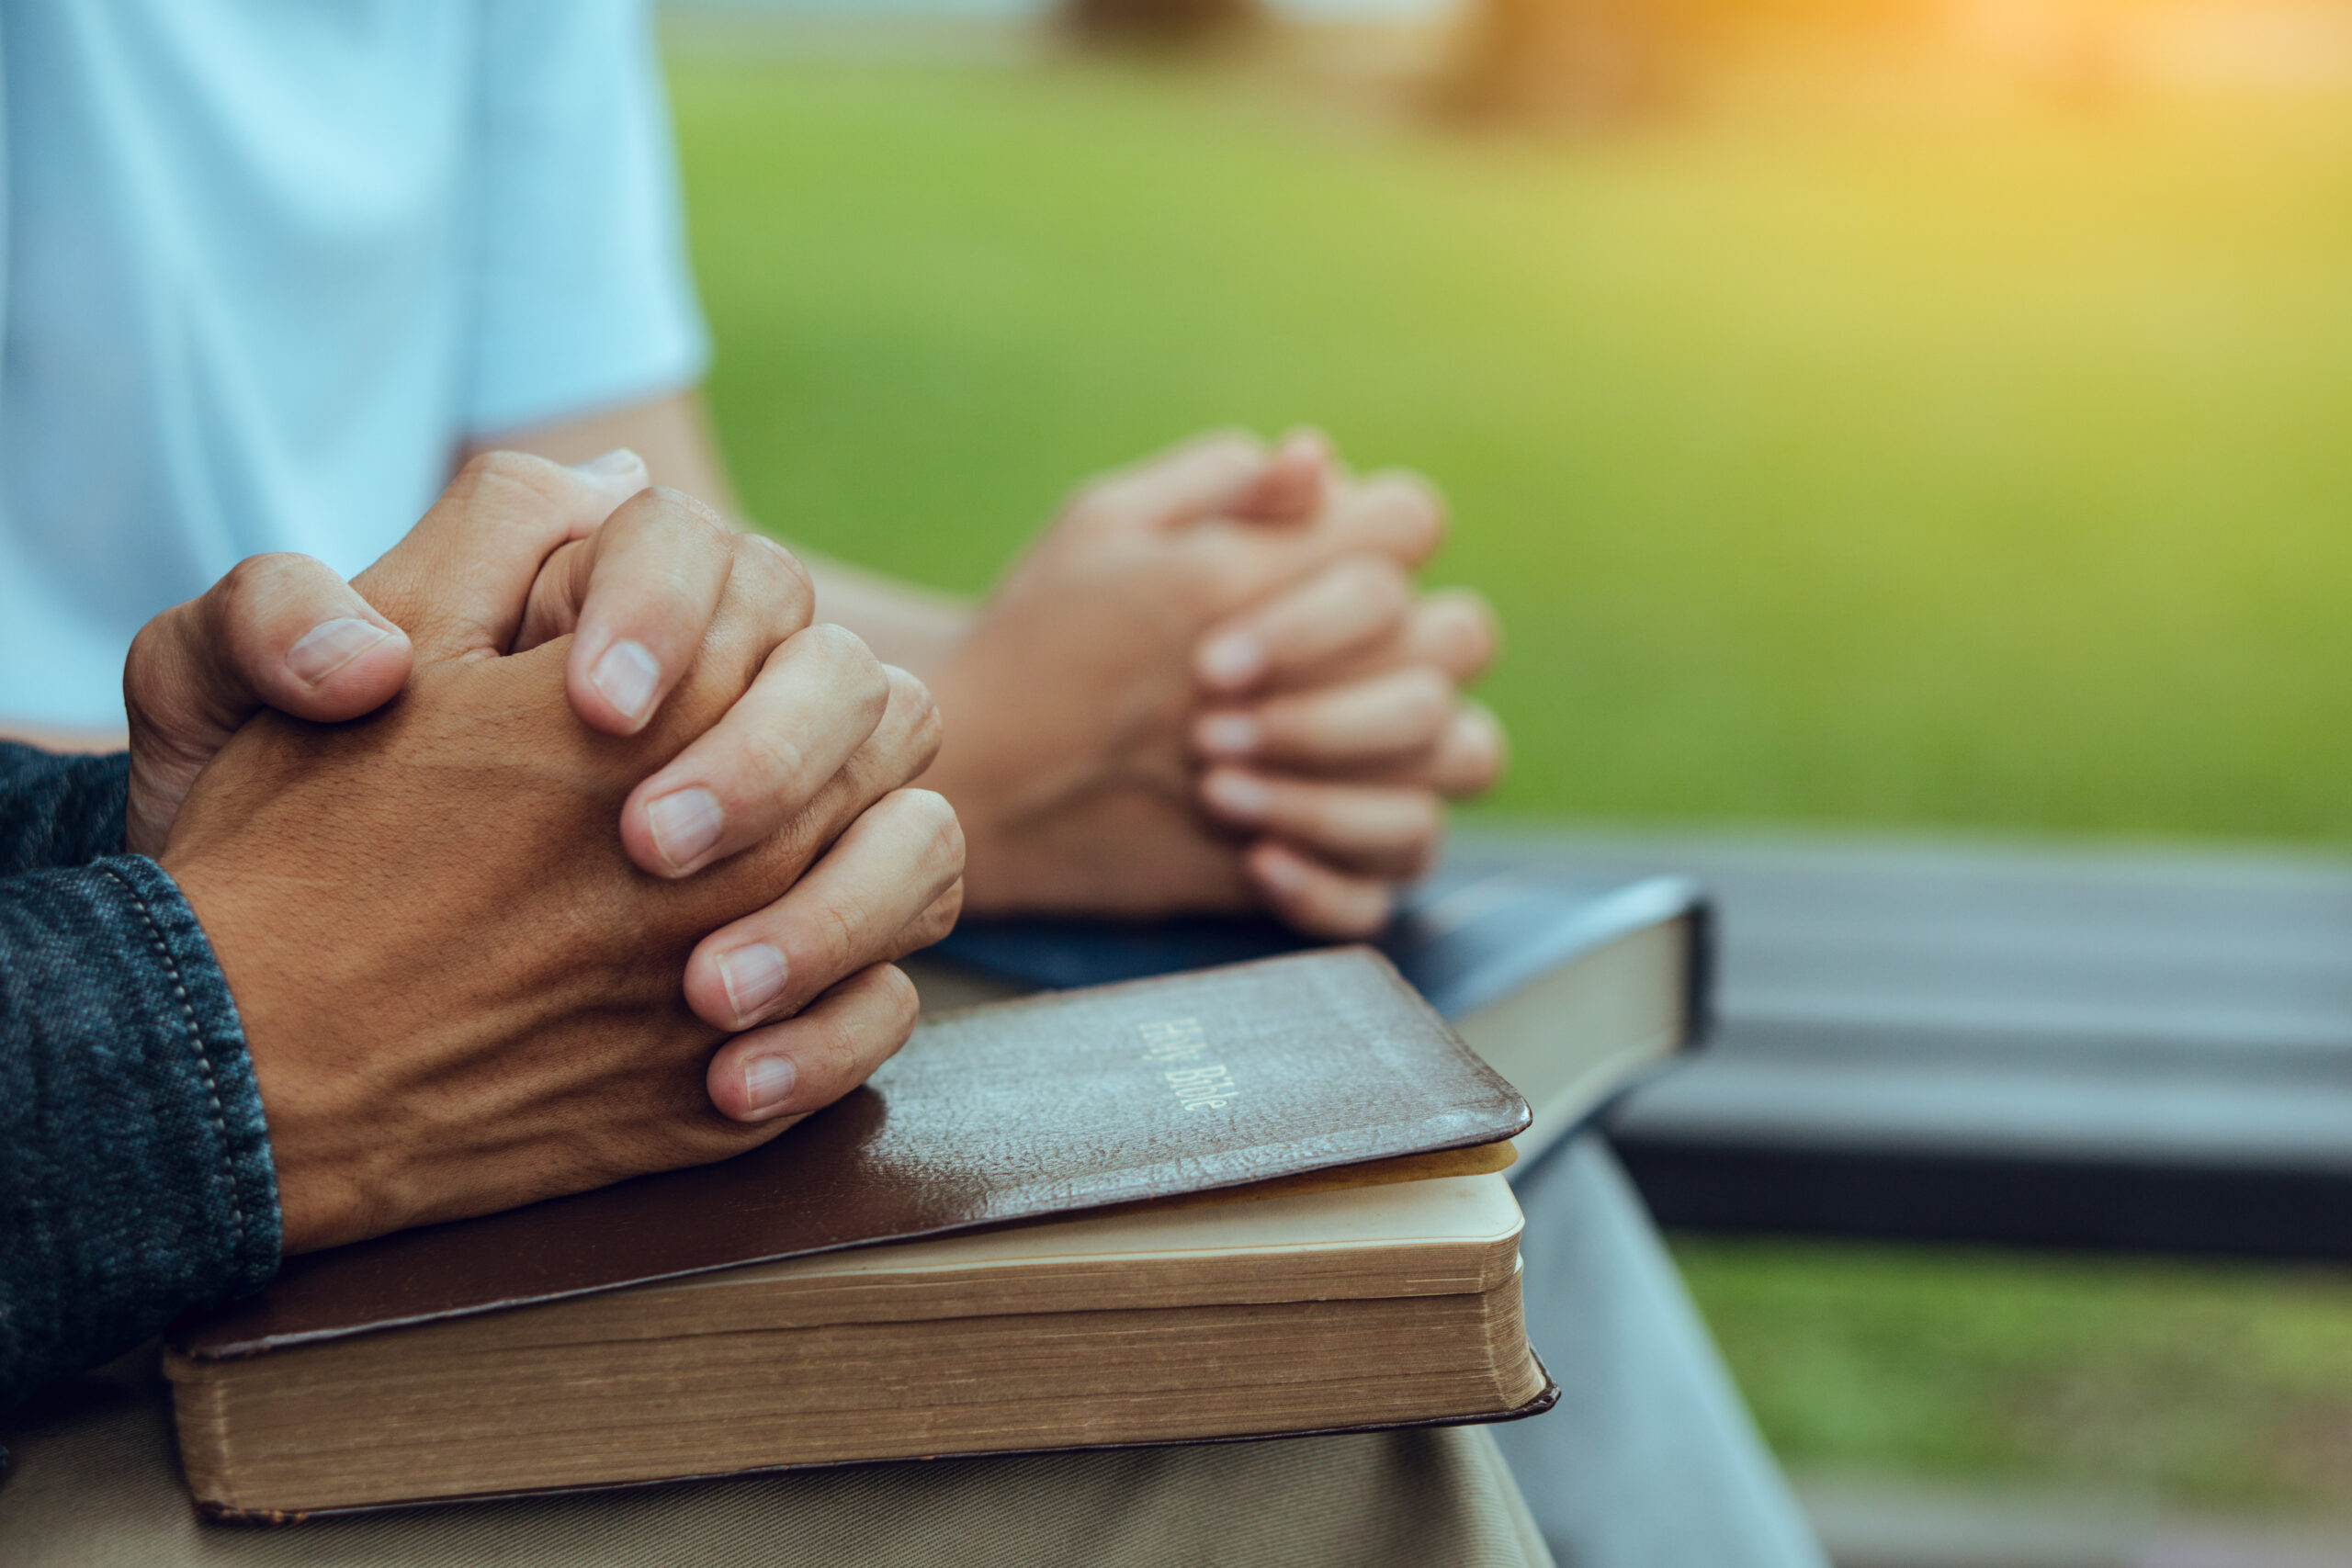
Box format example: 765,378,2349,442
174,947,1529,1359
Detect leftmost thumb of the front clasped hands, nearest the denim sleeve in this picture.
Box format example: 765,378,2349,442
122,555,414,853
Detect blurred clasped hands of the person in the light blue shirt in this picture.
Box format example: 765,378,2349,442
927,434,1503,938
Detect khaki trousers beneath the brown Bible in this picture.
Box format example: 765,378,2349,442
0,1352,1553,1568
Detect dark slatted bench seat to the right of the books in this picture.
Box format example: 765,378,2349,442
1453,835,2352,1258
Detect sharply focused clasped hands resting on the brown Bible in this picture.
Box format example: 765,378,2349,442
125,454,962,1251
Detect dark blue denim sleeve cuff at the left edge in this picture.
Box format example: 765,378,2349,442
0,745,277,1408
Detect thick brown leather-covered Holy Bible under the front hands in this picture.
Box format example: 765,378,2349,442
164,947,1555,1521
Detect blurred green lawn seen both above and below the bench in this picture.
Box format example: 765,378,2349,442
673,59,2352,1505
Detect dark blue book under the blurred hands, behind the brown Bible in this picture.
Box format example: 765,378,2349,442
908,863,1713,1168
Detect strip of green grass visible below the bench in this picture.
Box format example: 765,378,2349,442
1677,1241,2352,1512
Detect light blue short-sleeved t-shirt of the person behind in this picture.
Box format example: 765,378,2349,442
0,0,708,724
